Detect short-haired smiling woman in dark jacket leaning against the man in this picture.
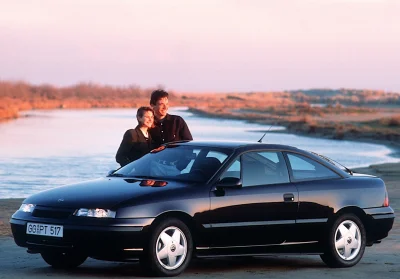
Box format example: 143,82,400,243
115,107,154,167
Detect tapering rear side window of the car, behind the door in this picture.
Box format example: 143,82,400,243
287,153,340,180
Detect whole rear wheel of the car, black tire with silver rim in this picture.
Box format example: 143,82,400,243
321,213,366,268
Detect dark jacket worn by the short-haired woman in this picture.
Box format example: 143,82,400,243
115,126,154,167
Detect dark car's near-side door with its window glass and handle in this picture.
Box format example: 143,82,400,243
209,151,298,247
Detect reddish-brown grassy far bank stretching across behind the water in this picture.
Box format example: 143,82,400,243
0,81,400,144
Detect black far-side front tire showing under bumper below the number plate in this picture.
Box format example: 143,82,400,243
40,252,87,269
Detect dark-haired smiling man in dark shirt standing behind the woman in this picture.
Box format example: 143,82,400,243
149,90,193,148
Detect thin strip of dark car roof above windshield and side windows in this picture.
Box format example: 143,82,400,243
167,140,300,151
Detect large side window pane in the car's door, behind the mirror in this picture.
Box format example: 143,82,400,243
242,151,289,187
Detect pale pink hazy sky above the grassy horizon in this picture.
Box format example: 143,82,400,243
0,0,400,92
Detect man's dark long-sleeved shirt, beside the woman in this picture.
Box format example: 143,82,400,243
149,114,193,146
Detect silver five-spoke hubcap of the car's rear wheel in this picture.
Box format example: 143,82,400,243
335,220,362,261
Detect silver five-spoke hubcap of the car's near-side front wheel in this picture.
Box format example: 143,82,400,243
156,226,187,270
